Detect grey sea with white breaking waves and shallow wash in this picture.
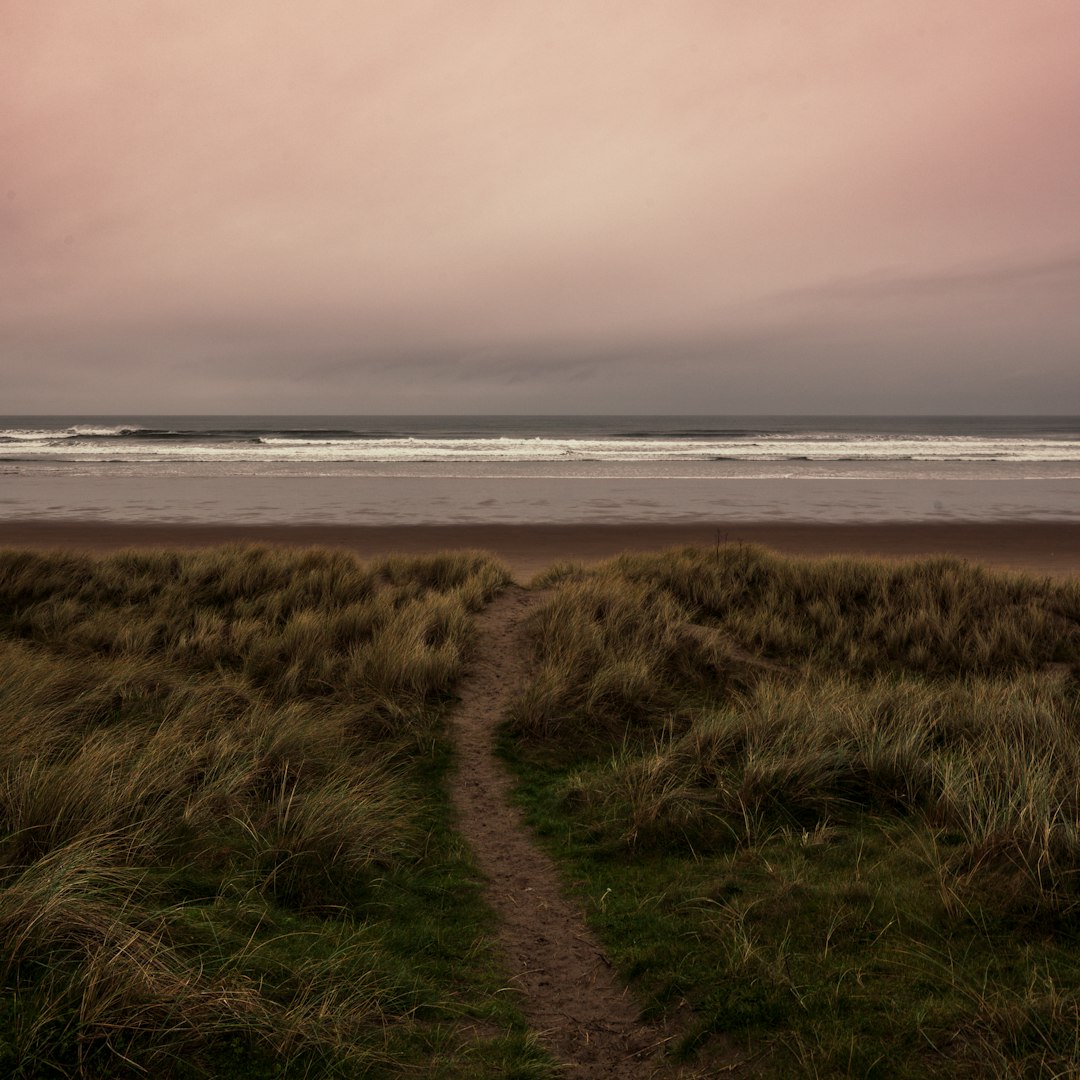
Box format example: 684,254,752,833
0,416,1080,525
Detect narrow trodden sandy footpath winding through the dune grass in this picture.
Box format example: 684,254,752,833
451,586,747,1080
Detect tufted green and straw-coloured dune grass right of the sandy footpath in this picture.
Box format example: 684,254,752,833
504,544,1080,1077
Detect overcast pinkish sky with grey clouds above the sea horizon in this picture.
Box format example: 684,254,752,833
0,0,1080,415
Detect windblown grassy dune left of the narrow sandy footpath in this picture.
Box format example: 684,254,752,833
0,548,545,1078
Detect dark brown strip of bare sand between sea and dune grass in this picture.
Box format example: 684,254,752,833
0,518,1080,580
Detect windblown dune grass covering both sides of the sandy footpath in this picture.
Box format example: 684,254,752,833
8,545,1080,1078
